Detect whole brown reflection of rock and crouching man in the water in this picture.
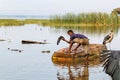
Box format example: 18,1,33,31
52,56,107,80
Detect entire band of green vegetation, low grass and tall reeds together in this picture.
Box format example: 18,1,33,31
0,8,120,27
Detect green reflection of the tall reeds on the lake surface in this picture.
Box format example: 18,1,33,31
50,26,120,36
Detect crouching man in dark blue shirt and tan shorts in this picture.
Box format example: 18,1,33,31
63,30,89,53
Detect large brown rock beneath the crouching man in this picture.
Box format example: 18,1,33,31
52,44,106,61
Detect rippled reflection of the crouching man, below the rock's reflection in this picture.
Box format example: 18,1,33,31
54,59,89,80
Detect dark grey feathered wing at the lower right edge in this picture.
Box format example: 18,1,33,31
100,50,120,80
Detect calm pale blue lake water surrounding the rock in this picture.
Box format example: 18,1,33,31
0,24,120,80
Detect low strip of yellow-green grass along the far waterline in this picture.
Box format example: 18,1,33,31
0,19,120,27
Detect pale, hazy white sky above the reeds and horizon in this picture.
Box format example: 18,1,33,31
0,0,120,15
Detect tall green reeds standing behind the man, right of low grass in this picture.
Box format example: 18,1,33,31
50,12,120,26
